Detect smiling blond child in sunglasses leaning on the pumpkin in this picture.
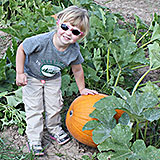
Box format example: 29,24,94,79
16,6,97,155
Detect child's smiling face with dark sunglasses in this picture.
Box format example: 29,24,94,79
57,22,83,45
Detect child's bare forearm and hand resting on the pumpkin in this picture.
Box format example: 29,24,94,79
71,64,98,95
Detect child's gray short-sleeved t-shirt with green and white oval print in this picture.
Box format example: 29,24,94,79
23,32,84,80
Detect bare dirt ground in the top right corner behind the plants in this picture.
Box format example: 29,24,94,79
95,0,160,23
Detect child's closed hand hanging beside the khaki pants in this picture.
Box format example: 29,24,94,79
16,73,27,86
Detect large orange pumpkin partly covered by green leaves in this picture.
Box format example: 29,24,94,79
66,94,124,147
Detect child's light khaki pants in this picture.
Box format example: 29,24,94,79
23,75,63,141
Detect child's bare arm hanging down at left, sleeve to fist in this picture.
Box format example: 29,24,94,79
16,43,27,86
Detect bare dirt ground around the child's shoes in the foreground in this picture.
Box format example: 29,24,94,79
0,126,97,160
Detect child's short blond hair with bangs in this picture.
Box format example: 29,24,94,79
56,6,89,36
